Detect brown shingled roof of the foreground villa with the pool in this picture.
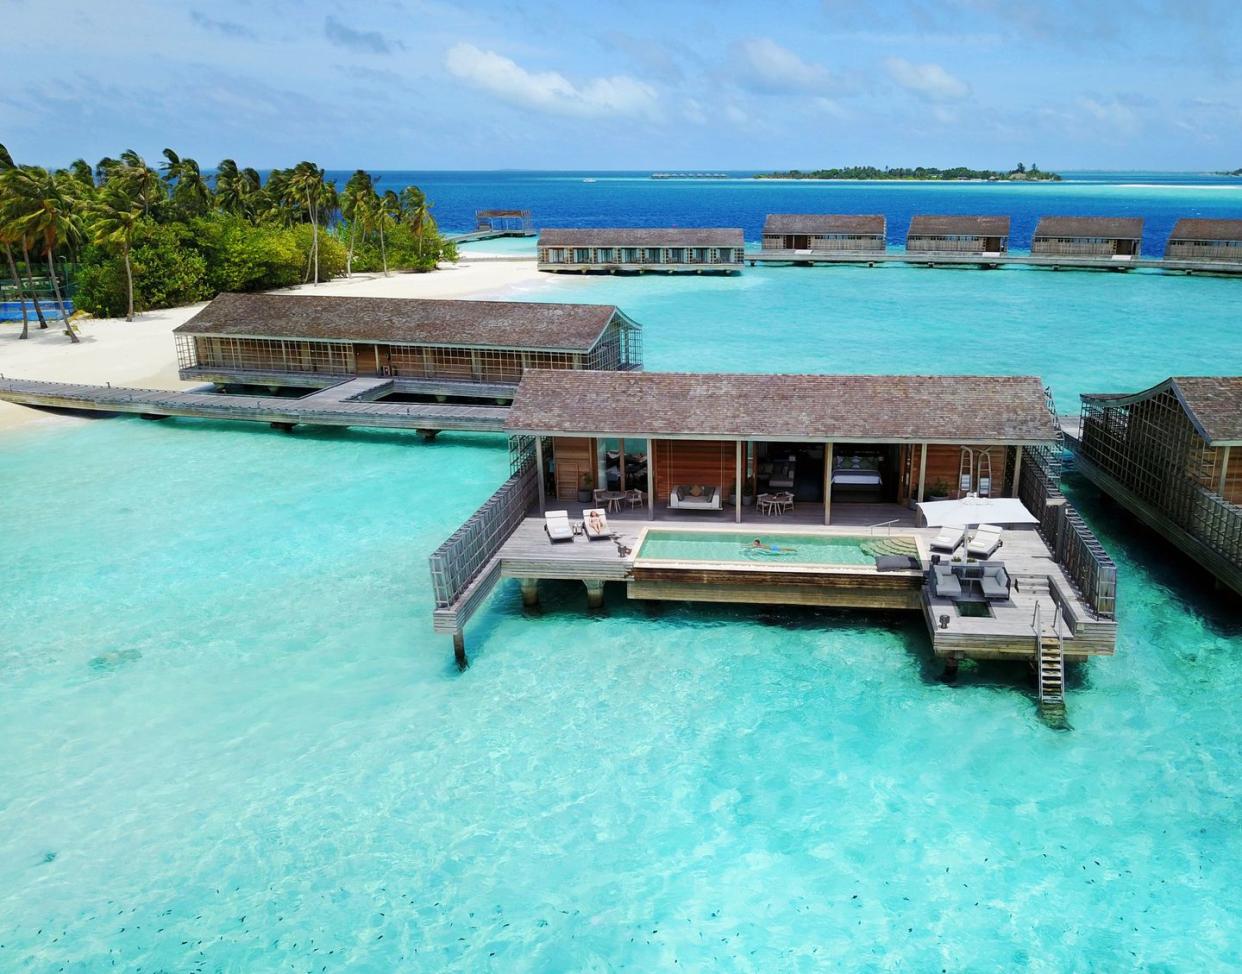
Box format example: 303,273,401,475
505,369,1057,444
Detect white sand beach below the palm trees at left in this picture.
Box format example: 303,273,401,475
0,251,549,431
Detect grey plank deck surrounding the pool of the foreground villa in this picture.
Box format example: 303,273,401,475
436,503,1117,660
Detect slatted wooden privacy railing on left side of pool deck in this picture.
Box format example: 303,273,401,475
430,448,539,609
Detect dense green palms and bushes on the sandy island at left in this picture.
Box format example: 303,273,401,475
0,145,457,332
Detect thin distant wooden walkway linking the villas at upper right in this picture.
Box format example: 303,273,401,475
746,250,1242,275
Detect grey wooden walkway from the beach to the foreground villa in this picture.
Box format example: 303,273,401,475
0,379,509,432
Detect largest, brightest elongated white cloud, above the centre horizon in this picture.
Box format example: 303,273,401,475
445,43,660,118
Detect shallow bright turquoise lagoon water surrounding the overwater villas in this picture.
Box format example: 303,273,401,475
0,262,1242,974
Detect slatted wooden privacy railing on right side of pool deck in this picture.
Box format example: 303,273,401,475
1018,450,1117,619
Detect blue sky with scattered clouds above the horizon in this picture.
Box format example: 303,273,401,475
0,0,1242,170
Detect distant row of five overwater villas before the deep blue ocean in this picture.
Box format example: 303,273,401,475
538,214,1242,273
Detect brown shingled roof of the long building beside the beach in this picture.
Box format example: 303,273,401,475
176,294,619,352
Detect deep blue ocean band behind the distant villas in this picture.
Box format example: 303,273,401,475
345,171,1242,257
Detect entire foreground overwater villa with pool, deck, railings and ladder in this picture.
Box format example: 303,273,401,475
431,370,1115,699
